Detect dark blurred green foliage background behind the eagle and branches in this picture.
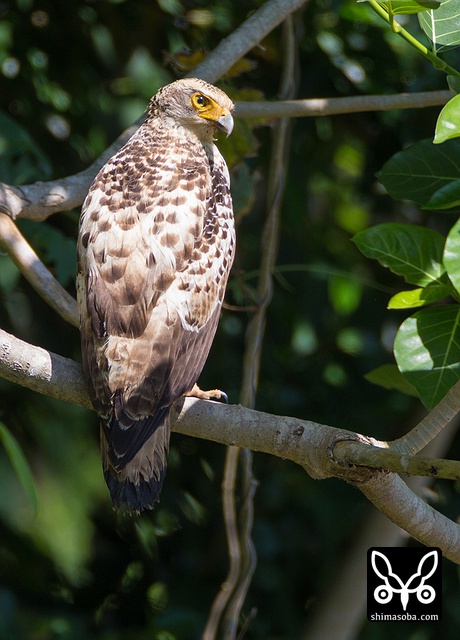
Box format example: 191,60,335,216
0,0,460,640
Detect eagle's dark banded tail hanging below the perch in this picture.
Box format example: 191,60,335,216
101,415,170,513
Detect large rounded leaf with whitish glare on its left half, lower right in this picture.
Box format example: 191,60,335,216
394,305,460,409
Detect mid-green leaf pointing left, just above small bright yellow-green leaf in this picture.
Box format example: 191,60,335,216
352,222,445,287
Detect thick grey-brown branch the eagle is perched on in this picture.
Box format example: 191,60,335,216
0,330,460,564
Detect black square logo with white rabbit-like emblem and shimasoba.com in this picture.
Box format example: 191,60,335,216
367,547,442,621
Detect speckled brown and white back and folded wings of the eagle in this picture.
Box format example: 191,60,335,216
79,120,234,469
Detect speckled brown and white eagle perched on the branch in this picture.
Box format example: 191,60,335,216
77,78,235,513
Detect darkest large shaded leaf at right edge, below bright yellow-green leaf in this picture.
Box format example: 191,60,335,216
377,138,460,205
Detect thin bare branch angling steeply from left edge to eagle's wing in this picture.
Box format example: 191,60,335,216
0,213,79,327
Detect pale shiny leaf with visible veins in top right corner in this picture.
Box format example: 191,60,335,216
418,0,460,50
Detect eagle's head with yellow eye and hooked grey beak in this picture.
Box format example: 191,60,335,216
149,78,234,138
